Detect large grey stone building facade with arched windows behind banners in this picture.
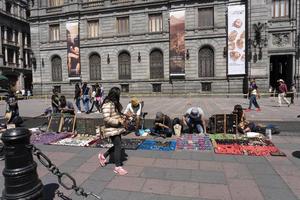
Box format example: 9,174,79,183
30,0,300,94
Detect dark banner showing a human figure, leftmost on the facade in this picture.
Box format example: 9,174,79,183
66,21,81,77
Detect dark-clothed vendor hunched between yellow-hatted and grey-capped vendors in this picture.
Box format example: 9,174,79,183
151,112,172,137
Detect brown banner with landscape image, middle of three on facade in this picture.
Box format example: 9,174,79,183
170,10,185,76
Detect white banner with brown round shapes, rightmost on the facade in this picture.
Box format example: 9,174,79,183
227,5,246,75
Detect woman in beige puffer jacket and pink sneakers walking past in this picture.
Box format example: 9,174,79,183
98,87,128,175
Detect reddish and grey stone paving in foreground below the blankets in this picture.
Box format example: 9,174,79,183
0,135,300,200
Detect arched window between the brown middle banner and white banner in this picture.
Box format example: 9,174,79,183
198,47,214,77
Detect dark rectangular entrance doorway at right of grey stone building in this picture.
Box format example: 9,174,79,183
270,55,293,88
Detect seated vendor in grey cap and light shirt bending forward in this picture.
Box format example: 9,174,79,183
182,107,206,134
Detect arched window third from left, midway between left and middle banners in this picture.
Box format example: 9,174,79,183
118,52,131,79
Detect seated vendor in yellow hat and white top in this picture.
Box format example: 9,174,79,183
124,97,142,130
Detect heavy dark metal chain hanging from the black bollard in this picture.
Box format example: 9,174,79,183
27,144,102,200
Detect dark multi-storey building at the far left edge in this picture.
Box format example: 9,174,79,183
0,0,32,90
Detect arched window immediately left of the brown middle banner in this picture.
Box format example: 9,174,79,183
150,50,164,79
